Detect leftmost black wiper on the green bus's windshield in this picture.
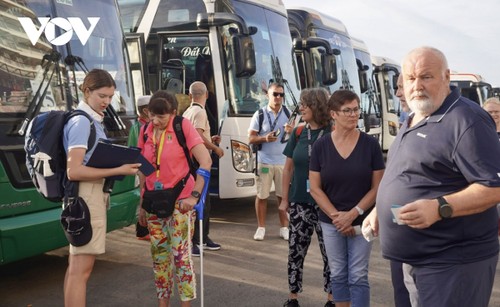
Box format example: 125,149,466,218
17,50,61,136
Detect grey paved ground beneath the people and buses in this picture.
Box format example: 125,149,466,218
0,199,500,307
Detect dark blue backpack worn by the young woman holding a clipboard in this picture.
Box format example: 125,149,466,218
24,110,96,202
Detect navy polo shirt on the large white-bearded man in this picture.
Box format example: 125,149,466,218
377,88,500,265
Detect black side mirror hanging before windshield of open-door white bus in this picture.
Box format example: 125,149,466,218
231,34,257,78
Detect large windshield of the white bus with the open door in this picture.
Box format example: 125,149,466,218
227,1,299,116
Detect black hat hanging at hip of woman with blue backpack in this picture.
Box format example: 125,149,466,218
61,197,92,246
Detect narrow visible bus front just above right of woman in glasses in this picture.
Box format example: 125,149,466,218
351,37,387,146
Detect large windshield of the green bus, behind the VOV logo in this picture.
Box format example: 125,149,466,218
0,0,134,117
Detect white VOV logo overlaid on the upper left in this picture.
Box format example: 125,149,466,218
17,17,101,46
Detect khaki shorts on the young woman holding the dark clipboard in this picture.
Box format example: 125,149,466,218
69,180,107,255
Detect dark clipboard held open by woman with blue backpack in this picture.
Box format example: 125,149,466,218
87,139,155,180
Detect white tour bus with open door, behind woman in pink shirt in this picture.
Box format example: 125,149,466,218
118,0,299,198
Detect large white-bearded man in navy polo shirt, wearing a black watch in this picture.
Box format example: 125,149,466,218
363,47,500,307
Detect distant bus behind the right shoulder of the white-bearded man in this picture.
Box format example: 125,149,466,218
450,72,493,106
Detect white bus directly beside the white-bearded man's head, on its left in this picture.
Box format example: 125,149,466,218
371,56,402,152
